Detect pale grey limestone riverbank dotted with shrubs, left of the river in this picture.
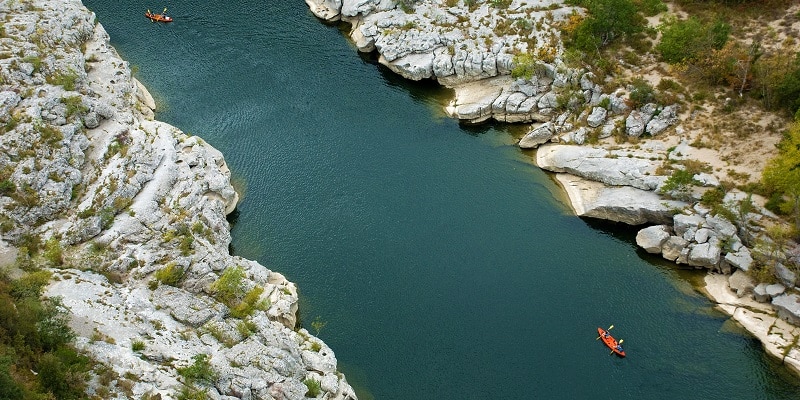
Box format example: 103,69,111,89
0,0,356,399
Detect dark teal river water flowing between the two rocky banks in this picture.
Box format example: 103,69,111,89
84,0,800,400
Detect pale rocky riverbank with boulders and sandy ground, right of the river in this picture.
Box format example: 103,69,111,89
306,0,800,373
